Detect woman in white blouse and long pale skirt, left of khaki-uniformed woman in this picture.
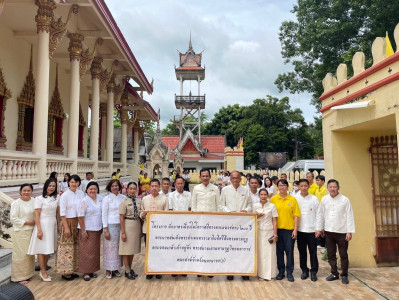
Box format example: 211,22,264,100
102,179,126,279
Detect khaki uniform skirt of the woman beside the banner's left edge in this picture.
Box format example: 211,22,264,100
119,219,141,255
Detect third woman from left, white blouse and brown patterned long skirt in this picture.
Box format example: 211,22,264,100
56,175,84,280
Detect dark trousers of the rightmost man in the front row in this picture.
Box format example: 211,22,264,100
325,231,349,276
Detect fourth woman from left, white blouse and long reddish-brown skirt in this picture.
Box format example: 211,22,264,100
78,181,103,281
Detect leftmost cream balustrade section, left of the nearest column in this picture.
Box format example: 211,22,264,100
0,151,39,186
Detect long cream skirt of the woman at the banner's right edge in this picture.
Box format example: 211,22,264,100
258,229,277,280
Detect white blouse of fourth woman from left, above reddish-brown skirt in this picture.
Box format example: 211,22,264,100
78,196,103,231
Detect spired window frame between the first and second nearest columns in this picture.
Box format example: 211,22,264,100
47,65,65,155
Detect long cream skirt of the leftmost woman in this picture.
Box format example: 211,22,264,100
11,229,35,282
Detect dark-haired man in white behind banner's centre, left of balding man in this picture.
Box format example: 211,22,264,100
191,169,220,211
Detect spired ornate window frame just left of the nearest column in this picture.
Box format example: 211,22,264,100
16,47,35,151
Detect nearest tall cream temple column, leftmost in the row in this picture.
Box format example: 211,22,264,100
32,1,55,183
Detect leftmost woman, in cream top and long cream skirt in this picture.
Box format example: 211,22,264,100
10,183,35,284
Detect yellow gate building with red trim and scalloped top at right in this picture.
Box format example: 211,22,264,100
320,24,399,267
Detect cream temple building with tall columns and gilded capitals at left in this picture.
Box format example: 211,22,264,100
0,0,157,186
